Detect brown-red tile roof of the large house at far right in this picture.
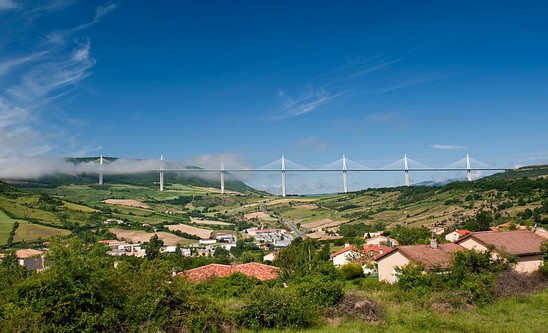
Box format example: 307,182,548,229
457,230,545,256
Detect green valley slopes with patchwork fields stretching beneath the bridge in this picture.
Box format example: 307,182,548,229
0,163,548,244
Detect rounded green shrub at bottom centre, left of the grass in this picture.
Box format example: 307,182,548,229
235,286,320,331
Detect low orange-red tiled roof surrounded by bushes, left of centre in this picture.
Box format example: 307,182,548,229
177,262,280,282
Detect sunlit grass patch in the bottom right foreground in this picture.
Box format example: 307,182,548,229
256,290,548,333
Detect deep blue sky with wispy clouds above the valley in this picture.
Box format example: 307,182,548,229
0,0,548,193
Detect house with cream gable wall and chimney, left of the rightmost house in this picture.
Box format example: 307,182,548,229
377,239,465,283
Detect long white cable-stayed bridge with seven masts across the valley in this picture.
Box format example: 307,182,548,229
96,154,510,197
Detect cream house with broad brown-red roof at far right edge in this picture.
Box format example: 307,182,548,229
456,230,546,273
